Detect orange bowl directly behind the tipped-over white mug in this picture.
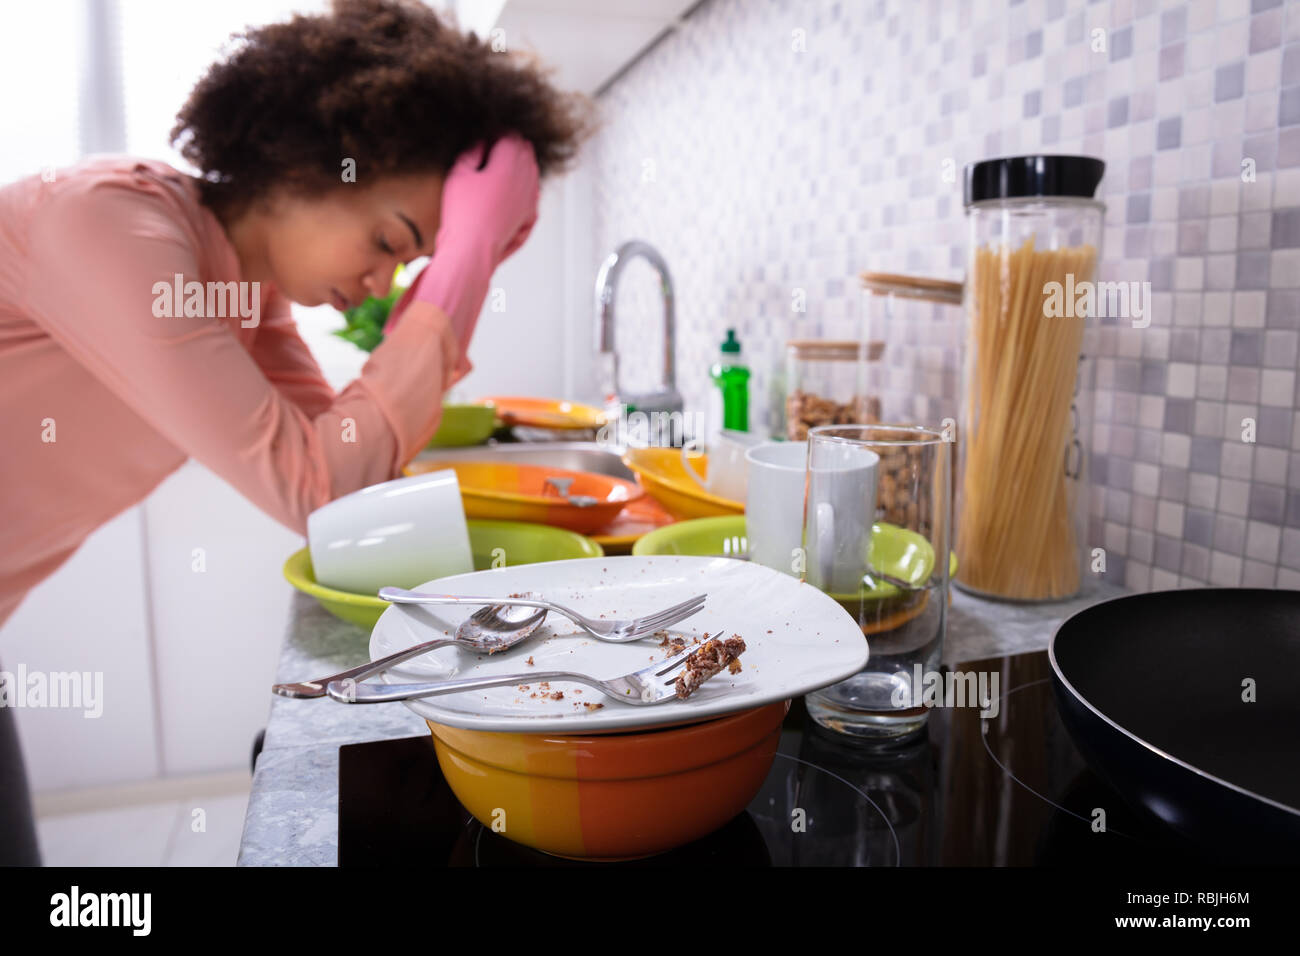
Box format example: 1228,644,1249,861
406,459,645,535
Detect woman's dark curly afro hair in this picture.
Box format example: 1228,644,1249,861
170,0,594,220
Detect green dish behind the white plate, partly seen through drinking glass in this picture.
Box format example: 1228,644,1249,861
632,515,957,601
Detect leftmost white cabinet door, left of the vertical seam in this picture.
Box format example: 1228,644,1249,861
0,506,161,791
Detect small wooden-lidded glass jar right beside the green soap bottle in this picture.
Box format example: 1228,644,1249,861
784,338,884,441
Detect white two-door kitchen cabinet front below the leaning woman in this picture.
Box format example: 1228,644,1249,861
0,462,304,791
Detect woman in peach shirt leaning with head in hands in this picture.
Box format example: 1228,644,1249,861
0,0,588,862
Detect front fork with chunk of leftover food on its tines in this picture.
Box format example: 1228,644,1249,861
325,631,722,705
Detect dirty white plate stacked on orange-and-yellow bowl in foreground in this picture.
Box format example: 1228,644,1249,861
371,555,867,860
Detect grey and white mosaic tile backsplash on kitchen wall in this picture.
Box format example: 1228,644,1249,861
592,0,1300,589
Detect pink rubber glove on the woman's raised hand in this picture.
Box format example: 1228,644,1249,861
385,133,541,388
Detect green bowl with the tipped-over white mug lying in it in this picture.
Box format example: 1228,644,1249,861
285,519,605,631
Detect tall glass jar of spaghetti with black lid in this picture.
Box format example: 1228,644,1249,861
956,156,1105,601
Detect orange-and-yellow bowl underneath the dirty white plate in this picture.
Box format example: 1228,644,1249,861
428,701,790,860
